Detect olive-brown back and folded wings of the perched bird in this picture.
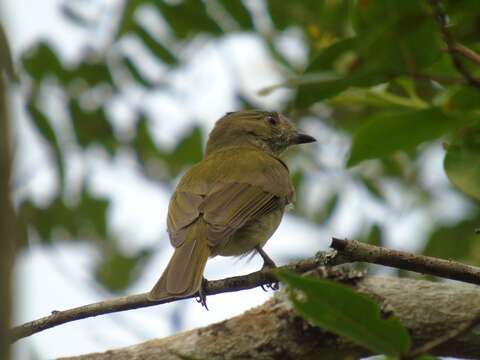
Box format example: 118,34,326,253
167,150,293,247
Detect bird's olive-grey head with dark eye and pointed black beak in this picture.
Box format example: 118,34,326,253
206,110,316,156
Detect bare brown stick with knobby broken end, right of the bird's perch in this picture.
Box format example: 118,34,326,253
330,238,480,285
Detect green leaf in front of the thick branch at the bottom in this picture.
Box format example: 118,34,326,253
276,271,411,356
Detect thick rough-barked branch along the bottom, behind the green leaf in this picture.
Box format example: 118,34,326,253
64,277,480,360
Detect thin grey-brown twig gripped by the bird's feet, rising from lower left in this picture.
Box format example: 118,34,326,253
10,253,336,341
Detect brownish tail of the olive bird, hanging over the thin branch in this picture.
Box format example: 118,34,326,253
148,218,210,300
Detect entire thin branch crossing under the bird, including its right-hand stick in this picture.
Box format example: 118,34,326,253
11,238,480,341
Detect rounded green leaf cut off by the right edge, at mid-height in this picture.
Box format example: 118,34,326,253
443,146,480,200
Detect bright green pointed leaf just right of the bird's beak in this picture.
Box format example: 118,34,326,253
347,108,450,166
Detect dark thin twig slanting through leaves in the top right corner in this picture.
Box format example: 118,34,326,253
429,0,480,89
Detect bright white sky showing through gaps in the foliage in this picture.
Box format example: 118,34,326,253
0,0,466,360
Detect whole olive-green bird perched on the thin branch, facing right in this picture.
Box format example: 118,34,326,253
149,111,315,307
